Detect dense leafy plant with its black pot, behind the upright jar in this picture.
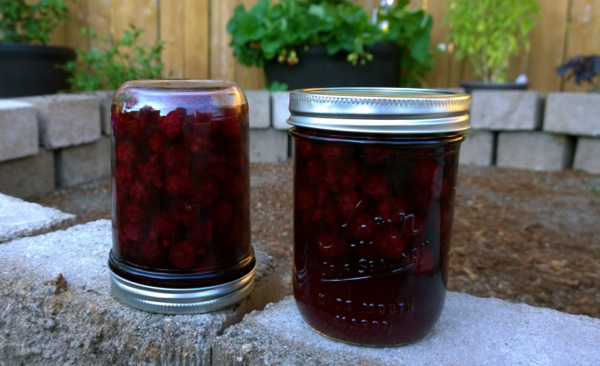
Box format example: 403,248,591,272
227,0,433,89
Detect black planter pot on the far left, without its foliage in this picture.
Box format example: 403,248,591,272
0,43,76,98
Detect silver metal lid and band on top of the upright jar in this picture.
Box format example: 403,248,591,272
287,88,471,134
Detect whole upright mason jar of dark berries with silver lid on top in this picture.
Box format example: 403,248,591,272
288,88,470,347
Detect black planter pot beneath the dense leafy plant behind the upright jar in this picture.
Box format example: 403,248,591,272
265,43,401,90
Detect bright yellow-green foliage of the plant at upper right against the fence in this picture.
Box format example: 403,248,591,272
442,0,540,82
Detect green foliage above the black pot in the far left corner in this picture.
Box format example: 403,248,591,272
0,0,69,44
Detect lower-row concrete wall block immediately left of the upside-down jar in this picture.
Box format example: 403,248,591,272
56,136,111,187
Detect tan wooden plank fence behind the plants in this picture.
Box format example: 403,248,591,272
51,0,600,92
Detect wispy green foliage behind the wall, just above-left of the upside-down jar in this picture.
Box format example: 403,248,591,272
65,24,163,91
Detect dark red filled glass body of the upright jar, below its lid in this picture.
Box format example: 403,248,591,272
291,127,461,345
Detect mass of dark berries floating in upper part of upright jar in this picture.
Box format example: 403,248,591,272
295,134,453,273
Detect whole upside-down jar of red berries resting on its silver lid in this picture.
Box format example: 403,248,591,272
108,80,256,314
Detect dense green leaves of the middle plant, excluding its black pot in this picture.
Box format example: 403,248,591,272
227,0,433,86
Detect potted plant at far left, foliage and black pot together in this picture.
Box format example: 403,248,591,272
0,0,75,97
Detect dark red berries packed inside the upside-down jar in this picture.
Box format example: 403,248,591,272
112,103,250,272
